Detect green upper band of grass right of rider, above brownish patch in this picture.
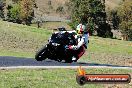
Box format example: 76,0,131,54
89,37,132,54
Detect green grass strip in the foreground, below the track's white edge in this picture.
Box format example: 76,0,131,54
0,69,132,88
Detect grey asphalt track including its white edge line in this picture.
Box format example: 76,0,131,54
0,56,132,69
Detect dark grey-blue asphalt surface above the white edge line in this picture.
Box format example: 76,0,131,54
0,56,132,68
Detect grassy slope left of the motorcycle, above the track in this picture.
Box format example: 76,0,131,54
0,21,51,57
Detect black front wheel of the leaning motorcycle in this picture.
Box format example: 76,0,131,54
35,46,47,61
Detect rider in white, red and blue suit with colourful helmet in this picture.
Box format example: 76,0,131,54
70,19,89,61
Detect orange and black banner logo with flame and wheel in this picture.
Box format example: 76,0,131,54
76,66,131,85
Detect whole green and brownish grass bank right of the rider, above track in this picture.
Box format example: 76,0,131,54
80,36,132,66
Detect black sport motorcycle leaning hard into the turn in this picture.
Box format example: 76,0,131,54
35,28,83,63
